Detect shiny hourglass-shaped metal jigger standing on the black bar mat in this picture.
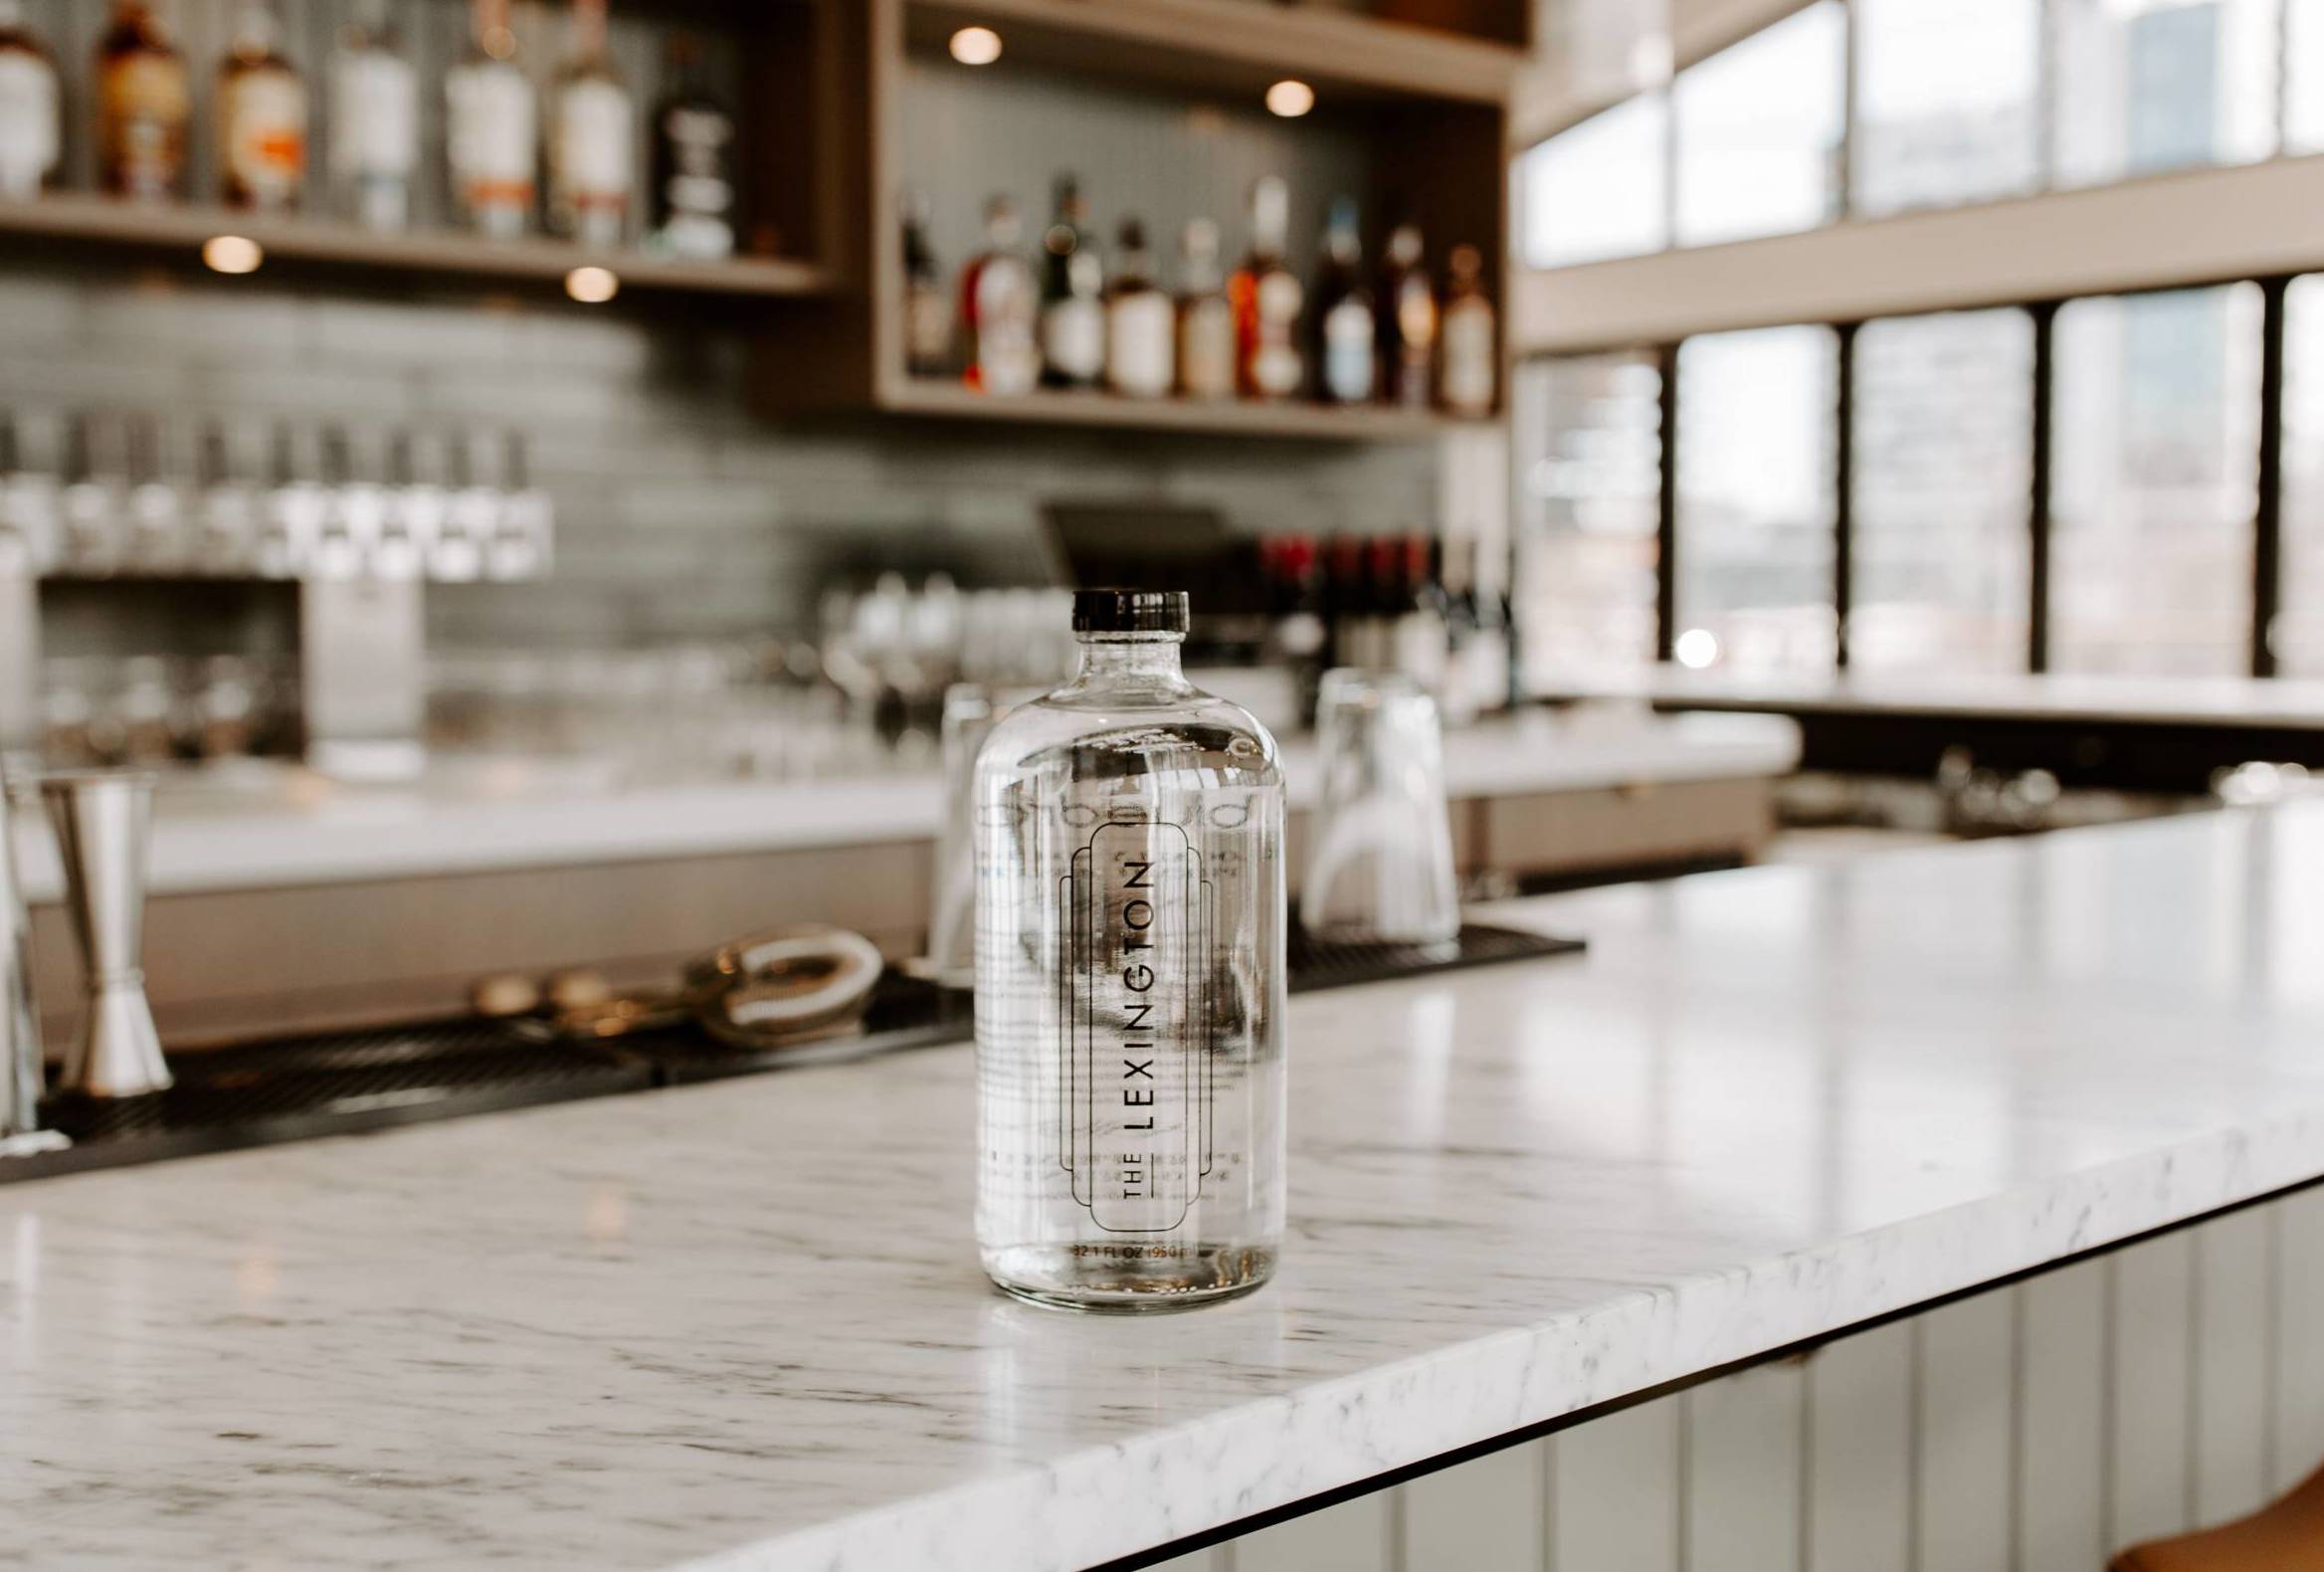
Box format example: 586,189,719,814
40,772,170,1097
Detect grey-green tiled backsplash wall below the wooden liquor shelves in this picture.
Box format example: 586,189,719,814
0,261,1437,649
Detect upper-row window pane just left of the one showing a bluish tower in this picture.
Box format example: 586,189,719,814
1849,0,2040,214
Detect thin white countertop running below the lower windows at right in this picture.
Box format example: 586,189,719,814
1541,665,2324,730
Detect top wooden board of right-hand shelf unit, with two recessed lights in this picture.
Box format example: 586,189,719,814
906,0,1524,104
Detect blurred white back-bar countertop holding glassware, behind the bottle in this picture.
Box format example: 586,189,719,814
4,711,1799,900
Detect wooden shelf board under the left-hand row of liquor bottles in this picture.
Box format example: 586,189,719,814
0,193,835,297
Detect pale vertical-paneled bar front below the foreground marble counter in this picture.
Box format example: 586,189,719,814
1208,1186,2324,1572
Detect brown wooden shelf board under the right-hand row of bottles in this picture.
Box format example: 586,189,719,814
878,377,1492,442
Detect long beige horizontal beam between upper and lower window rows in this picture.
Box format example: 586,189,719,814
1508,153,2324,356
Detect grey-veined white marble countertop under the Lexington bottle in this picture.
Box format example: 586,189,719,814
18,805,2324,1572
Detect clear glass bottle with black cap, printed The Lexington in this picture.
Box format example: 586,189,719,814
976,591,1282,1311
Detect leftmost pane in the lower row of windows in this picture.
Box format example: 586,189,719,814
1515,356,1661,688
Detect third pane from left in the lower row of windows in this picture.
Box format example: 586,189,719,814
1847,309,2034,672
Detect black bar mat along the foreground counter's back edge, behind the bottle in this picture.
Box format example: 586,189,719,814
0,923,1583,1184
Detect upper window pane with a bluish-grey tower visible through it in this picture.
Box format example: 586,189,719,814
2052,0,2280,186
